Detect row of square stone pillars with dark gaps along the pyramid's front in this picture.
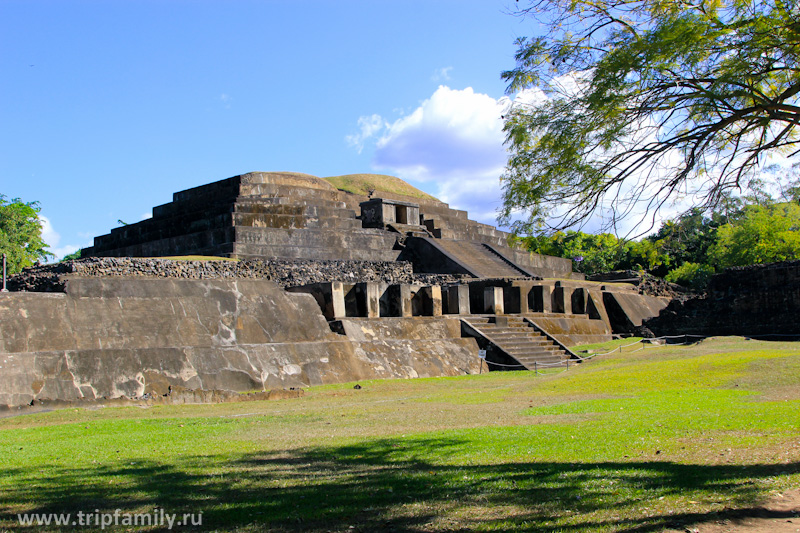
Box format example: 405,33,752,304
286,280,602,320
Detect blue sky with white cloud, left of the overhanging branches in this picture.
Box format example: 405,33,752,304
0,0,537,255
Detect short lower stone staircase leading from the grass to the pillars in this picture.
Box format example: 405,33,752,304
462,316,573,370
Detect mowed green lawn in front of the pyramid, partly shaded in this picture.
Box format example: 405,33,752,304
0,338,800,532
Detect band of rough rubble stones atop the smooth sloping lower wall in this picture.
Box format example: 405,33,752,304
8,257,460,292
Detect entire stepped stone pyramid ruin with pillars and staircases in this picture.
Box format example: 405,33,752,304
0,172,669,407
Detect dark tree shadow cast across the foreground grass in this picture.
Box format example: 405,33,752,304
0,438,800,532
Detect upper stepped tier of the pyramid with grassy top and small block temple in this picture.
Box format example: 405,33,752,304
82,172,575,278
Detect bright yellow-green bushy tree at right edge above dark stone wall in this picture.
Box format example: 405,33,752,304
709,202,800,267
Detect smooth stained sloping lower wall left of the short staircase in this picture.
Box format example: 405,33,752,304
0,275,481,409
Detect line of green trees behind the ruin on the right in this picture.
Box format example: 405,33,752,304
519,187,800,289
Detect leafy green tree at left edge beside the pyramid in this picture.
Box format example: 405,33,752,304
0,194,53,274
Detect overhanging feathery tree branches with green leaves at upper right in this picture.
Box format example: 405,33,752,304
498,0,800,234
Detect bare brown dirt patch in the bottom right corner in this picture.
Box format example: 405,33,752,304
665,489,800,533
